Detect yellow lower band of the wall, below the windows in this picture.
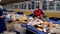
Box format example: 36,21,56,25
7,9,60,18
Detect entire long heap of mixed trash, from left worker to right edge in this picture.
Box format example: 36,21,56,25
3,11,60,33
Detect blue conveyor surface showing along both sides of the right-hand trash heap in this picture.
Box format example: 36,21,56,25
22,20,60,34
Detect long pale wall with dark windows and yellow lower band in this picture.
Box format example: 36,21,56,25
3,0,60,18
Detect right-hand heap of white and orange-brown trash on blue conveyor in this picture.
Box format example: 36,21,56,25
22,17,60,33
